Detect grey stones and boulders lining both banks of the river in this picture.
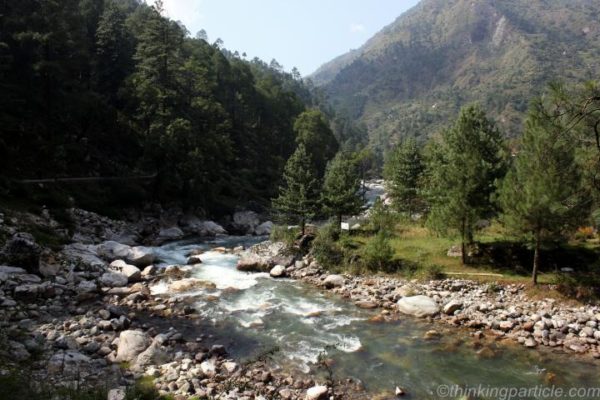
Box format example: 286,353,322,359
0,206,600,400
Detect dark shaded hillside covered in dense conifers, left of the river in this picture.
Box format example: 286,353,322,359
0,0,364,216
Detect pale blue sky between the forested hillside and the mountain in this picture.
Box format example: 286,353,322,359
150,0,418,76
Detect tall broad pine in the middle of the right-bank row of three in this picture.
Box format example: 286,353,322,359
426,105,505,263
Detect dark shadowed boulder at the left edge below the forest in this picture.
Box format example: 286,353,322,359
0,232,42,274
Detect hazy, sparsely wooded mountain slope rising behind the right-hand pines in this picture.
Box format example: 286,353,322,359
311,0,600,149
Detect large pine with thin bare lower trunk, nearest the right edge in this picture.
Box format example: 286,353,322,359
500,102,585,284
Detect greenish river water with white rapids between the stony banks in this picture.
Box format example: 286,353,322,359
148,237,600,399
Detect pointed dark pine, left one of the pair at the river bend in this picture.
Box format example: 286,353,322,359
273,144,319,235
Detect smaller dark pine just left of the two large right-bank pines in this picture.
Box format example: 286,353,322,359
384,138,423,217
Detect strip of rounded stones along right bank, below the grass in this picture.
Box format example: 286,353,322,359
258,245,600,359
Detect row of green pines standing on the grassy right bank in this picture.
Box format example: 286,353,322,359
384,83,600,283
